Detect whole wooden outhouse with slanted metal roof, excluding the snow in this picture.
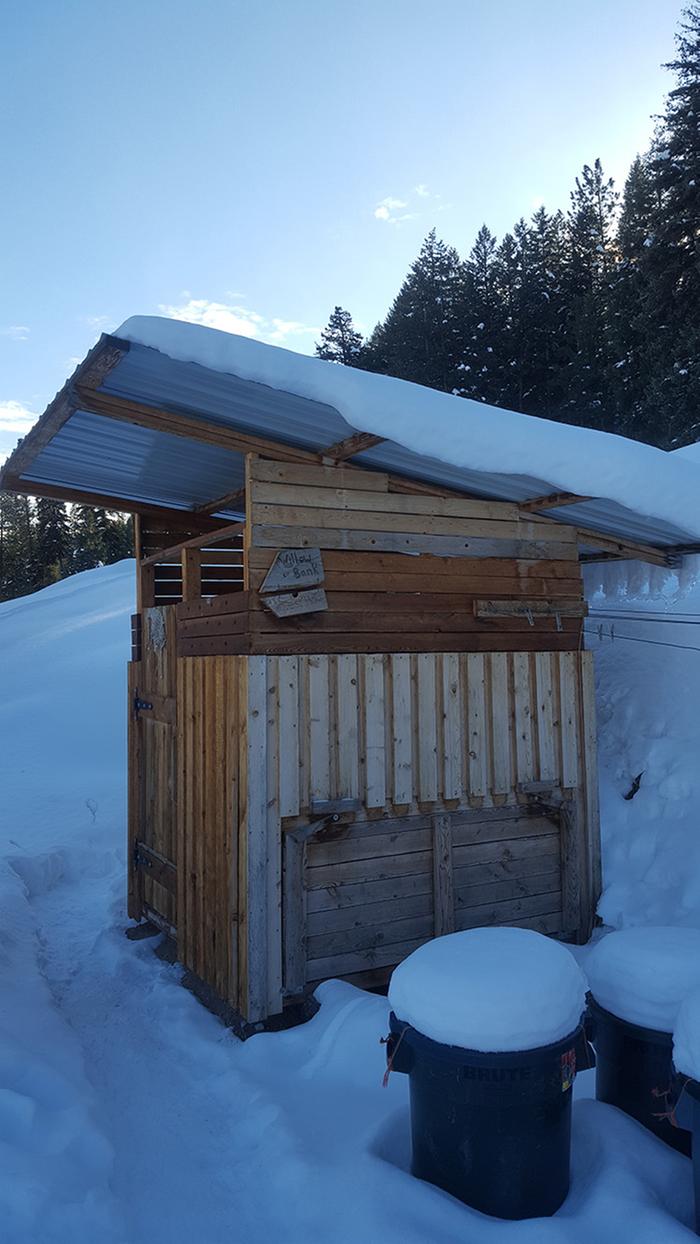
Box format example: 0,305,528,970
1,321,696,1021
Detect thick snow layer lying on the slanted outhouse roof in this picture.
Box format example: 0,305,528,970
116,316,700,539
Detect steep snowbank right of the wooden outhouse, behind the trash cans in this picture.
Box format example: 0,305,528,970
586,559,700,928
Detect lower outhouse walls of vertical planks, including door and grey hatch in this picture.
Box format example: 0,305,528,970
129,631,599,1020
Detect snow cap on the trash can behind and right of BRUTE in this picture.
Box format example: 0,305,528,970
586,927,700,1033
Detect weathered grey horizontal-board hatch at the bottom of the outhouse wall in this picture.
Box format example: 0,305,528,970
302,809,566,991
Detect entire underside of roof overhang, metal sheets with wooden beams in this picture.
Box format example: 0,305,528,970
0,335,698,562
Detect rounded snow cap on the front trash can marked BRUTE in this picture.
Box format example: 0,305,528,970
389,928,586,1054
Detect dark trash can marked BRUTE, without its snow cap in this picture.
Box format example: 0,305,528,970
387,1013,583,1218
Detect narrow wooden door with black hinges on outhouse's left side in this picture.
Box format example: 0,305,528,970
128,608,178,932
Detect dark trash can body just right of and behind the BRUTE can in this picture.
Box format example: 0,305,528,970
589,999,691,1157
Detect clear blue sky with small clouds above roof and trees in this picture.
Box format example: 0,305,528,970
0,0,681,458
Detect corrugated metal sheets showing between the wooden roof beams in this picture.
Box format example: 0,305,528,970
13,343,693,545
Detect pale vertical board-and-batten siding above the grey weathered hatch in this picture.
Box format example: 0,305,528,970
274,652,594,817
